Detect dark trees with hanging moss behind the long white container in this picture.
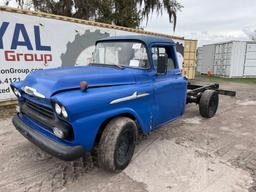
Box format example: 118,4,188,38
16,0,182,30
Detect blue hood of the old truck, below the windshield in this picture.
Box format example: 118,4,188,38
19,66,135,98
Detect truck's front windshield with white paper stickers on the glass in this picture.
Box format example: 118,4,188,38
93,41,148,68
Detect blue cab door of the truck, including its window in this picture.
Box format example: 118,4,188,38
152,44,187,128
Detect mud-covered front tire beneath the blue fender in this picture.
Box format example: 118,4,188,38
97,117,137,172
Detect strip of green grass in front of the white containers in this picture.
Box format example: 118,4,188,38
196,74,256,84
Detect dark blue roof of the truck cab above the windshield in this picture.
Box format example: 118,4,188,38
97,35,175,46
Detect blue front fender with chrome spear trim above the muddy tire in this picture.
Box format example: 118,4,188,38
53,84,153,151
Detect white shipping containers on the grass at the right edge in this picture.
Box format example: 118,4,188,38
198,41,256,78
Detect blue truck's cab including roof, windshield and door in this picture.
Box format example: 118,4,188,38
94,36,187,126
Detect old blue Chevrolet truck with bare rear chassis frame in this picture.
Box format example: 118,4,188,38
11,35,235,171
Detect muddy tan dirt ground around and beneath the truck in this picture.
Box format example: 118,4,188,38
0,80,256,192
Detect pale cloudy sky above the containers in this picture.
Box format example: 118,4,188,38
142,0,256,46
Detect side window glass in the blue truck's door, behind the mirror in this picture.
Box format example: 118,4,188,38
152,46,176,71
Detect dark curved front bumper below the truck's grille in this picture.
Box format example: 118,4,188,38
12,115,85,161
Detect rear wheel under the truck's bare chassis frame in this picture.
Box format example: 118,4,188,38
199,90,219,118
